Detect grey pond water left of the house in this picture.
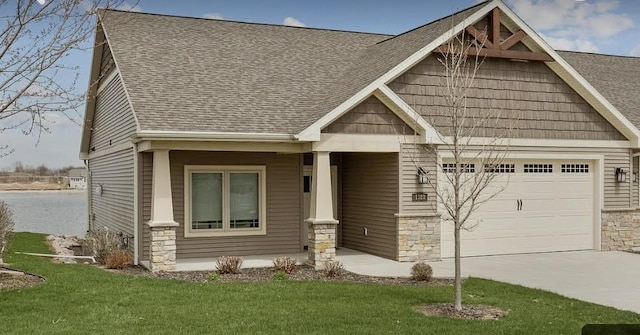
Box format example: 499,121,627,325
0,191,87,237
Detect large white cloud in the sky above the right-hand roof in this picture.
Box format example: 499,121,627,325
508,0,634,52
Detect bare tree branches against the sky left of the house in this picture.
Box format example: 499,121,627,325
0,0,130,157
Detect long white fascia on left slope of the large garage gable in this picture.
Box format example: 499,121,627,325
296,0,502,141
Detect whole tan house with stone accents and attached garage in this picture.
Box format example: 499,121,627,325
80,0,640,271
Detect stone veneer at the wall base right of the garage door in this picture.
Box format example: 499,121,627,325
601,210,640,251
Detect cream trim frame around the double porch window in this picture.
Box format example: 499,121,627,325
184,165,267,237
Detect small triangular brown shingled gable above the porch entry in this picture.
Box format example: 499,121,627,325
322,96,414,135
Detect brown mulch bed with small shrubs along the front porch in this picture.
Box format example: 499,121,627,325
116,265,453,286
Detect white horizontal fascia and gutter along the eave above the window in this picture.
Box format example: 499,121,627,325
136,130,295,142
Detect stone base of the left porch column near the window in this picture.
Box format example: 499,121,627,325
147,222,178,272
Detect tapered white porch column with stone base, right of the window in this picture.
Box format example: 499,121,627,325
306,151,338,270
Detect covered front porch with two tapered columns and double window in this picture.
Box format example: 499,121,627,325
136,136,439,271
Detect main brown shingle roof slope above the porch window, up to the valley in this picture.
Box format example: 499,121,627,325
101,11,388,134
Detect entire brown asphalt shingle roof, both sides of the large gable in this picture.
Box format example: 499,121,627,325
100,3,640,135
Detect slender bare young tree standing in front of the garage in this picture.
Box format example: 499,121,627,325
413,28,512,310
